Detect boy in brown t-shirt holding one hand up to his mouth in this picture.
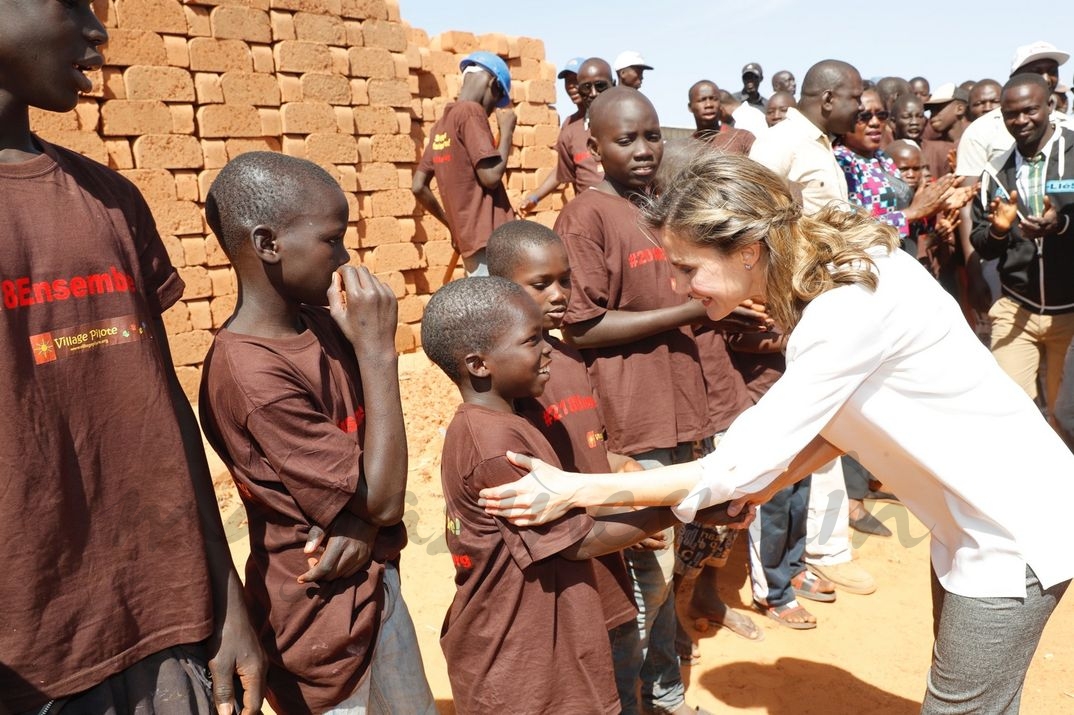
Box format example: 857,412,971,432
201,151,436,714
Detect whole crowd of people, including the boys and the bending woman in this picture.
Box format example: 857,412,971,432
0,0,1074,715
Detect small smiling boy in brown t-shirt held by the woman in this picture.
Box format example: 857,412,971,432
421,277,738,714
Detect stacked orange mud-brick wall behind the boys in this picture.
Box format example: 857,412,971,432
32,0,563,398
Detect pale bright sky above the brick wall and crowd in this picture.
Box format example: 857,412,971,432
400,0,1074,128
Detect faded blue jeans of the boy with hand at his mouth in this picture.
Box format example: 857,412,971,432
323,564,436,715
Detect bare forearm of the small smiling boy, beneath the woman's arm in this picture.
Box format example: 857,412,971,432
560,504,749,560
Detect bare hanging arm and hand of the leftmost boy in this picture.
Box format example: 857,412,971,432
153,317,265,715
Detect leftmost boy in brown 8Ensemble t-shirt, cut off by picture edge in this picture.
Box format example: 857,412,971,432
0,0,263,715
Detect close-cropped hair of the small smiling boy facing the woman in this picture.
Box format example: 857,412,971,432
421,276,529,384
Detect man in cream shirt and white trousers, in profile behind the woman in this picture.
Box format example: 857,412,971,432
750,60,876,594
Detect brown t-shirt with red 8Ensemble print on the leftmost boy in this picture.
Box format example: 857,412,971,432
0,140,213,712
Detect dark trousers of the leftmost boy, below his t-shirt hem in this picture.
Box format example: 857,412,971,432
24,644,216,715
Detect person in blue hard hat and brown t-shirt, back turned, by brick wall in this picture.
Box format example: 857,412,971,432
411,52,516,276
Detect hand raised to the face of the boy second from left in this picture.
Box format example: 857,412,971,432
329,265,398,363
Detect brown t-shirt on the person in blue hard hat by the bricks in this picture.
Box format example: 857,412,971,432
419,101,511,257
